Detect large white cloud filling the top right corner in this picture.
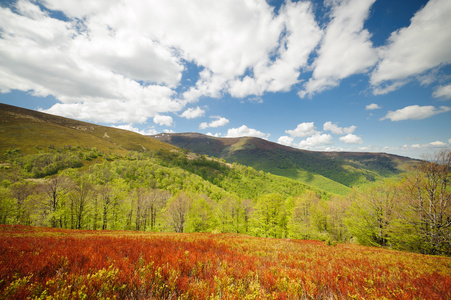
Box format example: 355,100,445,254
370,0,451,94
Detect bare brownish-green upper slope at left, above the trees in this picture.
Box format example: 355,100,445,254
0,103,176,154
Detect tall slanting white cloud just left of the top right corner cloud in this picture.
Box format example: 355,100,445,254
298,0,378,98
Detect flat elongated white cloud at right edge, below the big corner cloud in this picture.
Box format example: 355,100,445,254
381,105,451,121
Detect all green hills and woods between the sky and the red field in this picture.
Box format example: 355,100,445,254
0,106,451,255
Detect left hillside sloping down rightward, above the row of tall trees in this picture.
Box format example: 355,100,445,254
0,104,325,198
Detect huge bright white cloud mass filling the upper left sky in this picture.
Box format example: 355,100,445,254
0,0,290,123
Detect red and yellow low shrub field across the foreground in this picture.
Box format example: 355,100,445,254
0,226,451,299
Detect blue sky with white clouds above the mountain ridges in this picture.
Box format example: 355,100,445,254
0,0,451,158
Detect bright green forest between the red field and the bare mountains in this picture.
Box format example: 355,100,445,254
0,146,451,255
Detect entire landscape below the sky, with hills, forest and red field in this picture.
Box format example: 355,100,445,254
0,104,451,299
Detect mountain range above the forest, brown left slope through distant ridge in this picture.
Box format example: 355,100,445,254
0,104,417,194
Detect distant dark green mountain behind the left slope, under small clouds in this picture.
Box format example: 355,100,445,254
152,133,418,194
